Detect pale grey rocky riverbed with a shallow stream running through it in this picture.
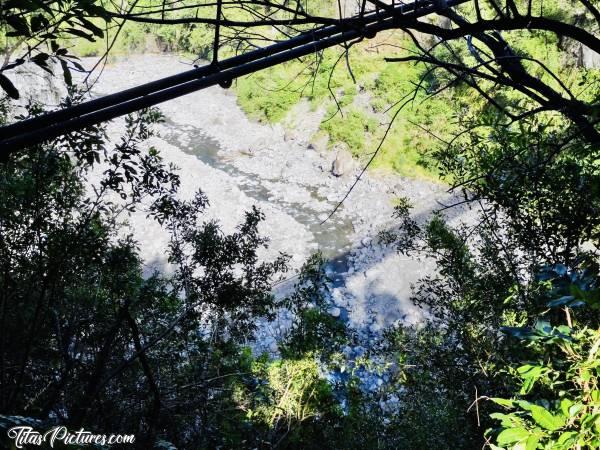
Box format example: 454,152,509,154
5,55,470,368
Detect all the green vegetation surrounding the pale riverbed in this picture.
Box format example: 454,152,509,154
0,0,600,450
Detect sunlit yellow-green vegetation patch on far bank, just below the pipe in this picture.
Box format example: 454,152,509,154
236,39,458,180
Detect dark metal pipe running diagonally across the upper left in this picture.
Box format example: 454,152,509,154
0,0,468,156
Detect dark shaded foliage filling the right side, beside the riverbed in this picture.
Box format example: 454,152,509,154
376,105,600,449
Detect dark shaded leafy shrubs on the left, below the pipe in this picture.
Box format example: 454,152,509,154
0,100,292,448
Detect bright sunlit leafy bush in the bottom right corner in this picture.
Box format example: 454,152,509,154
488,266,600,450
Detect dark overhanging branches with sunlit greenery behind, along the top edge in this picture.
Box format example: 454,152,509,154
0,0,600,144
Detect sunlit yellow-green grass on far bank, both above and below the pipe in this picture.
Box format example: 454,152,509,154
54,2,580,179
